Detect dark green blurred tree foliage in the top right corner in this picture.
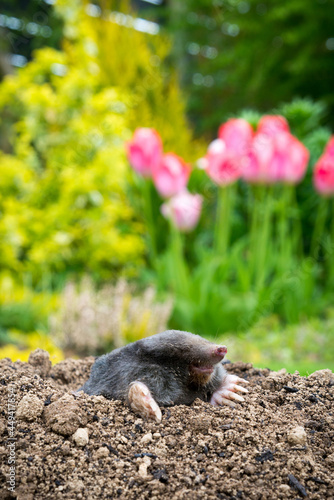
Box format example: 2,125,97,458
165,0,334,135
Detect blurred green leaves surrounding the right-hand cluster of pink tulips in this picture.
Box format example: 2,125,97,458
155,99,334,335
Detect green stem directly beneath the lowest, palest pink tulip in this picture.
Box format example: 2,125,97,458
170,222,190,297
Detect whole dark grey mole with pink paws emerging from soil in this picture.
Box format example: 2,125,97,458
77,330,248,422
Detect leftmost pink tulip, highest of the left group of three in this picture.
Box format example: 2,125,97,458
127,128,162,177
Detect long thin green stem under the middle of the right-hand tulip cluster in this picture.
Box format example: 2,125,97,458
255,187,273,290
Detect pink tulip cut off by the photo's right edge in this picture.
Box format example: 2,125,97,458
313,136,334,196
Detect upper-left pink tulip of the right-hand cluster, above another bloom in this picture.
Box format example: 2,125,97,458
218,118,254,157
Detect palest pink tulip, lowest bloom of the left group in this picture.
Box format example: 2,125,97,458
161,190,203,231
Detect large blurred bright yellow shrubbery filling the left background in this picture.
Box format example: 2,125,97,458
0,0,202,344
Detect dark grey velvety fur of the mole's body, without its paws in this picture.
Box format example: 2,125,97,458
78,330,226,406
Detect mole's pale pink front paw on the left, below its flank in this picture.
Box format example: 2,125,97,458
128,381,162,422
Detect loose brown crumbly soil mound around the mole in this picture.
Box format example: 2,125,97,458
0,351,334,500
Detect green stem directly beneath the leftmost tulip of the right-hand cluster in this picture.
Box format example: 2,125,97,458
214,185,234,258
